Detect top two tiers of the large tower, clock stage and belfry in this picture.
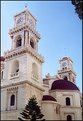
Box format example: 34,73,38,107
9,9,40,51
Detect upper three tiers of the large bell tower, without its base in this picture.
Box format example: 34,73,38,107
5,9,44,86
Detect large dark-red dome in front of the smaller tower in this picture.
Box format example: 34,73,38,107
51,80,79,90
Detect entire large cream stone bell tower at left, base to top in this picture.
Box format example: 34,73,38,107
1,9,44,120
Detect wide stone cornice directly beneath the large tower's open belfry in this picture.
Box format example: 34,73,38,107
4,45,44,63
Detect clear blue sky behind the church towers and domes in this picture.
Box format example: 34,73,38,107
1,1,82,90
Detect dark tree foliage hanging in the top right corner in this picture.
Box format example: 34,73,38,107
71,0,83,20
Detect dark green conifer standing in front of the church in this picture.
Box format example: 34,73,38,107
18,96,45,121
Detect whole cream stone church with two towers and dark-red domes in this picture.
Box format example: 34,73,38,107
0,9,82,121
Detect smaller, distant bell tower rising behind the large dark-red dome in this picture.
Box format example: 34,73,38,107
58,57,76,83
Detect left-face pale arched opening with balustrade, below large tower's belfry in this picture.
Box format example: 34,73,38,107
11,60,19,76
